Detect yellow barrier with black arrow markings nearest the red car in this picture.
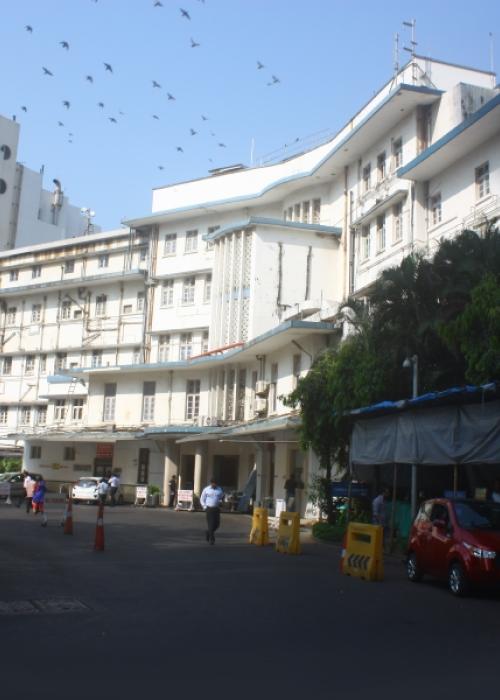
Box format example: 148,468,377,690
342,523,384,581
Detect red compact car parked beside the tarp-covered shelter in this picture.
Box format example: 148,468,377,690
406,498,500,596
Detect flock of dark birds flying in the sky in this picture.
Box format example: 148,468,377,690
21,0,281,170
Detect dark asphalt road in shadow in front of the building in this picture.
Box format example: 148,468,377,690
0,504,500,700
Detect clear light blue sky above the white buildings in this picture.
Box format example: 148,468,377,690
0,0,500,230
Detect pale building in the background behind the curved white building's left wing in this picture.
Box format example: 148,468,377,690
0,116,100,250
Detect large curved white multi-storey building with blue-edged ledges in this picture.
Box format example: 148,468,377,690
4,58,500,510
